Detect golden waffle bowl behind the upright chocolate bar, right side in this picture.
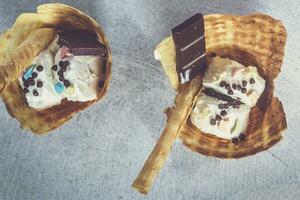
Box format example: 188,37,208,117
155,14,287,158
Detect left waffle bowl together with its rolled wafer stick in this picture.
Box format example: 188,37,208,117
0,4,112,134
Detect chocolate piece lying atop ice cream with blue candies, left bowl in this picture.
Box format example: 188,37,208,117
58,30,106,56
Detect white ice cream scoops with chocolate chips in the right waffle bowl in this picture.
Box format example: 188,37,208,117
190,57,265,139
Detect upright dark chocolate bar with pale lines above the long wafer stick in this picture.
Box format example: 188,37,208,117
172,14,206,83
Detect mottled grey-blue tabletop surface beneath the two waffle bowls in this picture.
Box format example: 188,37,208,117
0,0,300,200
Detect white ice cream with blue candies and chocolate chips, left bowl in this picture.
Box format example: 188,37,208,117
19,37,101,110
